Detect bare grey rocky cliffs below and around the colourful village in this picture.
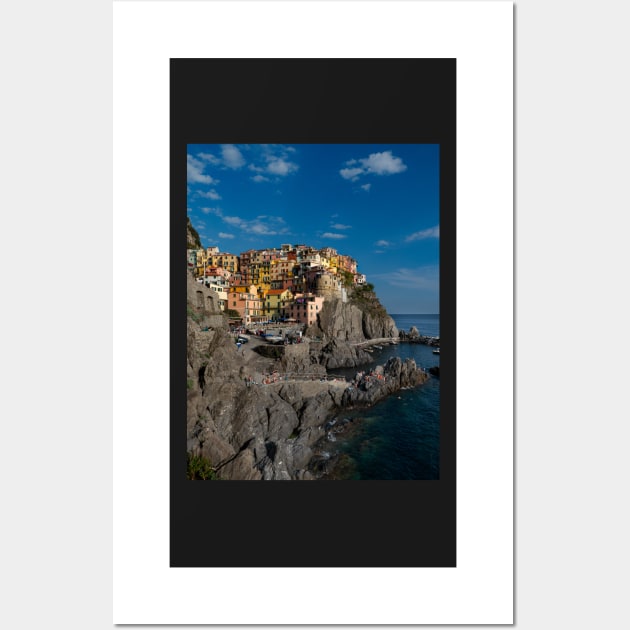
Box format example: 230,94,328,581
187,276,432,480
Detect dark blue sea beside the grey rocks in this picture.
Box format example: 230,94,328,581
320,314,440,480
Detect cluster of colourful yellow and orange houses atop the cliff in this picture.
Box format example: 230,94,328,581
187,235,366,326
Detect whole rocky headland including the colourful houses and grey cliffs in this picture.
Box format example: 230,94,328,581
186,221,430,480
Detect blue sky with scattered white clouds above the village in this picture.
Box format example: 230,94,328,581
187,144,440,313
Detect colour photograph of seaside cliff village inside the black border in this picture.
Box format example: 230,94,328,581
188,142,441,481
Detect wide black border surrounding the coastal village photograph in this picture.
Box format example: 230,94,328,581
172,58,456,572
